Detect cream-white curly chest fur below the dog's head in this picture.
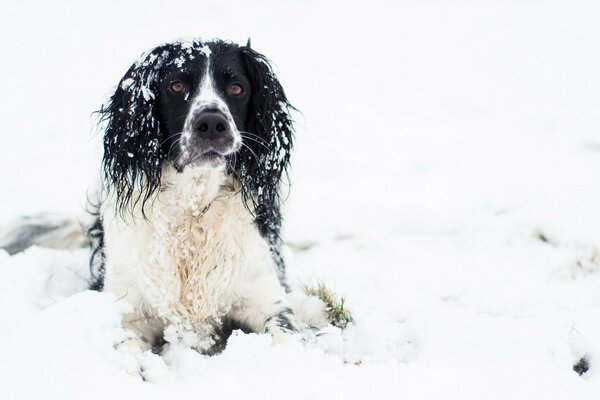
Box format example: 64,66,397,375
105,167,273,334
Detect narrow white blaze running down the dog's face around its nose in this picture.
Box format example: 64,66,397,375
180,54,242,157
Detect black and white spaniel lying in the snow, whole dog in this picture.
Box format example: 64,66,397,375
3,40,328,358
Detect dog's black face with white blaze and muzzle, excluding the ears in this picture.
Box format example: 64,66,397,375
156,46,253,170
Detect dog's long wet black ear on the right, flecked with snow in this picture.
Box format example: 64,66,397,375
240,47,295,276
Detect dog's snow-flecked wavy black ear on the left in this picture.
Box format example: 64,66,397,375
99,47,166,211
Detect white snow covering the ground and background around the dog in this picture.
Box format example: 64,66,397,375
0,0,600,400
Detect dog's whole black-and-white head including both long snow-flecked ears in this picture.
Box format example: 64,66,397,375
100,41,293,218
